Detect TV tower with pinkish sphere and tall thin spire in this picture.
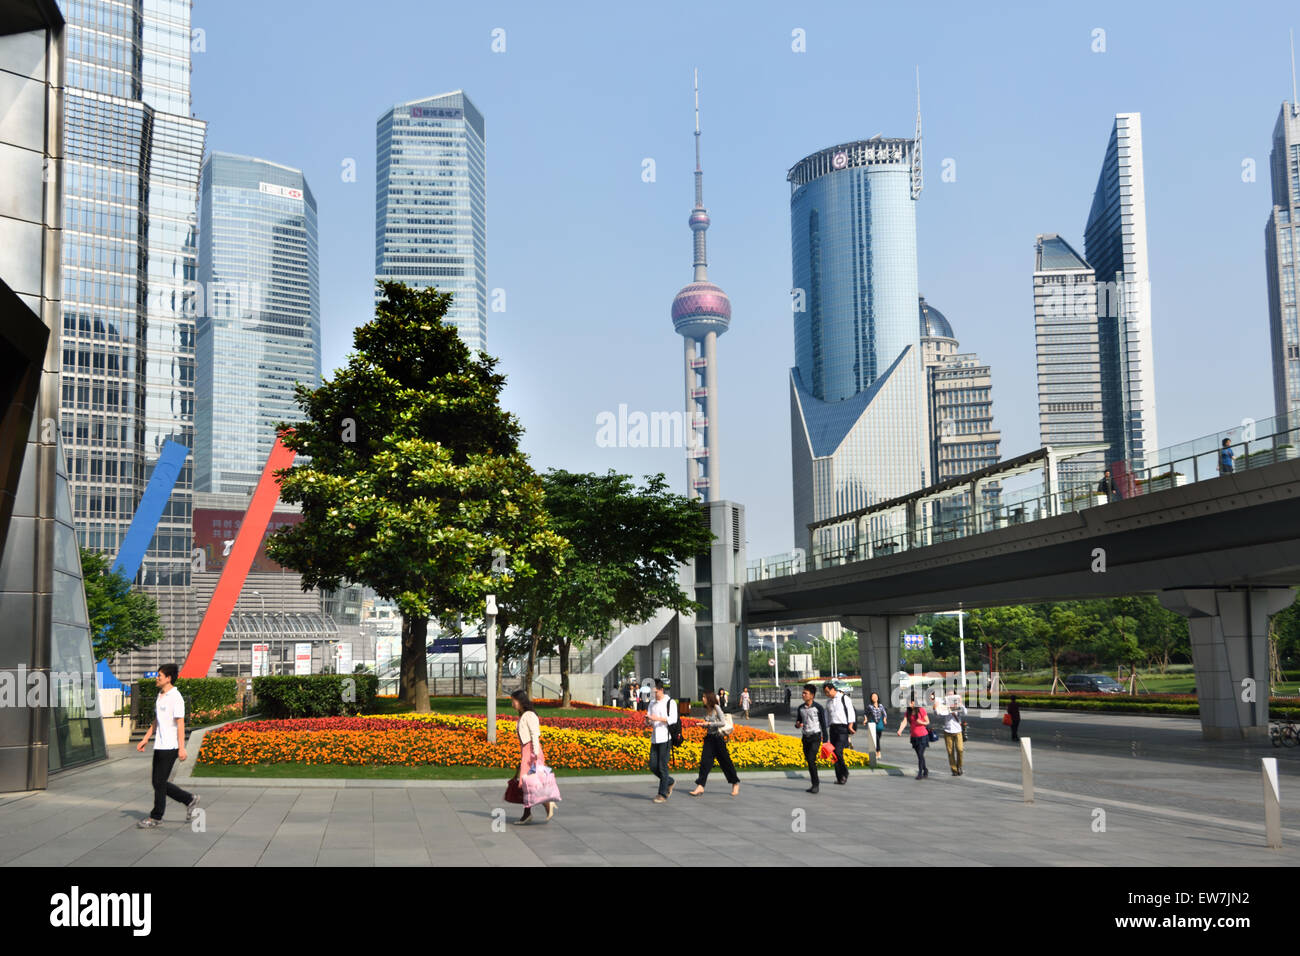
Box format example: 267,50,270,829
672,70,731,501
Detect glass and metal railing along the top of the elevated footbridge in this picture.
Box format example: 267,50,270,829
749,416,1300,581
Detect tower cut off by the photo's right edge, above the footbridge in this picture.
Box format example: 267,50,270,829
1264,92,1300,428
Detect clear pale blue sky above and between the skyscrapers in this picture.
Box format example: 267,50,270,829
192,0,1300,559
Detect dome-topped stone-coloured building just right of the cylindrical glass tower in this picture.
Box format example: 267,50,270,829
920,297,1002,522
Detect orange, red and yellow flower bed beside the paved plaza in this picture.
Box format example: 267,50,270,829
198,714,867,771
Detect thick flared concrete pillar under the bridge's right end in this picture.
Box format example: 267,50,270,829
1160,588,1295,740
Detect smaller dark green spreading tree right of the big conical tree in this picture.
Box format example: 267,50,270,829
512,471,714,706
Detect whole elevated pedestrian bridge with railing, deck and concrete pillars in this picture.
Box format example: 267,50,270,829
745,420,1300,737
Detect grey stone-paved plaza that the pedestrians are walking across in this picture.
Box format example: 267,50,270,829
0,711,1300,866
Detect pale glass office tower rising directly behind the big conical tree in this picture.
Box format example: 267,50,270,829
374,90,488,351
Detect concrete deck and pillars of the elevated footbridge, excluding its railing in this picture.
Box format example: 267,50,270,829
745,460,1300,737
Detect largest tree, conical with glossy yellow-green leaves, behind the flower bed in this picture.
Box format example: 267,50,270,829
267,282,564,713
